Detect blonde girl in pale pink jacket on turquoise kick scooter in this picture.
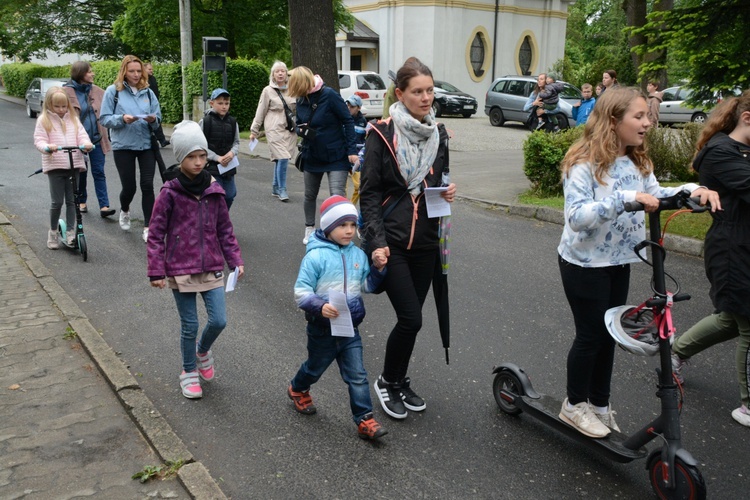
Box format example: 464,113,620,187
34,87,94,250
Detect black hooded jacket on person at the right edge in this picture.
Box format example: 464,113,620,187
693,132,750,318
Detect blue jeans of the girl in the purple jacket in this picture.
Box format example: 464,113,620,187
172,286,227,372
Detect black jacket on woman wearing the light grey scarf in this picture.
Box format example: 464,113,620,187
359,119,449,250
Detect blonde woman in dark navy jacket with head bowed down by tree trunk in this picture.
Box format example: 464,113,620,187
287,66,358,245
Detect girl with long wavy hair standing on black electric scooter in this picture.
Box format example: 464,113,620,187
557,87,721,438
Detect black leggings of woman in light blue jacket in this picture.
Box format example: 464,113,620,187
112,149,156,227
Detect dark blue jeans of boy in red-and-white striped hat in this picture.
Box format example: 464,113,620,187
292,323,372,424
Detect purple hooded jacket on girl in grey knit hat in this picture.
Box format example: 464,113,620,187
147,179,244,279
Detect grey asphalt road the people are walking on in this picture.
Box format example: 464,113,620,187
0,101,750,499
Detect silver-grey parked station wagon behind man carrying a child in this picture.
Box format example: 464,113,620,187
484,76,582,128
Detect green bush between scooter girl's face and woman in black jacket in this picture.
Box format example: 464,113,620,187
646,123,703,182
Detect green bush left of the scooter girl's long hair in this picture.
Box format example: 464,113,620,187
523,127,583,196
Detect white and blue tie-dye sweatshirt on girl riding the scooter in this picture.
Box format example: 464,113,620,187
557,156,699,267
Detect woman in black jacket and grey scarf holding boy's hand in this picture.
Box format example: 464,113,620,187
360,57,456,419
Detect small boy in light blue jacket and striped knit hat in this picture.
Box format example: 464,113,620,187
287,195,388,439
